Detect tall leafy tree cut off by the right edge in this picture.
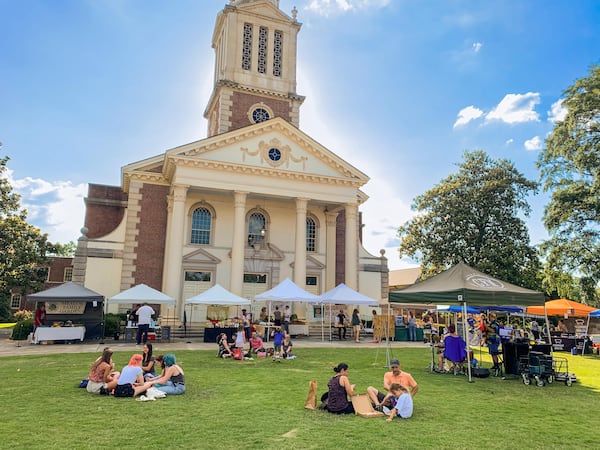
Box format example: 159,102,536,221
537,66,600,304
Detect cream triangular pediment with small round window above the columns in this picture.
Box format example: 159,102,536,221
166,117,369,187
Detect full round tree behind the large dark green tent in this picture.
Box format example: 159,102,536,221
398,151,539,288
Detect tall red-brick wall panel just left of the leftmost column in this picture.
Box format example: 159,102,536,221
134,183,169,290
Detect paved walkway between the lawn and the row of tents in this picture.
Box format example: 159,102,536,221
0,330,425,357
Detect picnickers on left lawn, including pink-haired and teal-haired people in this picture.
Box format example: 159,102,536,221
86,343,185,397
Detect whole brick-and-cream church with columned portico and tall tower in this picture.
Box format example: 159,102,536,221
73,0,388,321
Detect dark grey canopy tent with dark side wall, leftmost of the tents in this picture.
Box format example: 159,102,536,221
27,282,104,339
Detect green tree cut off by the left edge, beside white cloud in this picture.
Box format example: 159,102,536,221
0,157,56,319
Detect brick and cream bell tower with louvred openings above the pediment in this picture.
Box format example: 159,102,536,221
204,0,304,137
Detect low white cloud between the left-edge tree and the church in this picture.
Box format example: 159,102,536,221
7,169,87,243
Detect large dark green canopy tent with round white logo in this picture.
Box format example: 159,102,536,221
389,263,544,381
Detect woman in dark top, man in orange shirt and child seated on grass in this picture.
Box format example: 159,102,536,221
323,359,419,422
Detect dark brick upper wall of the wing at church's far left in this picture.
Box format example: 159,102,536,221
84,183,127,239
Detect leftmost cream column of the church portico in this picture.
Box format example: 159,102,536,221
163,185,189,311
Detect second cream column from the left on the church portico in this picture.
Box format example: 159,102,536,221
229,191,248,295
